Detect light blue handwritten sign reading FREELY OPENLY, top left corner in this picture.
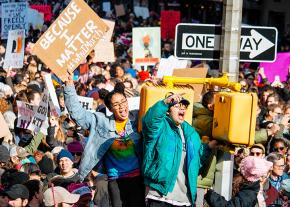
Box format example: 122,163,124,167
1,2,28,39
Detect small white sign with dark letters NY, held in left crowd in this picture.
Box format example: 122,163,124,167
16,101,37,129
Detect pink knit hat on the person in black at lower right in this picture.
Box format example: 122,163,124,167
240,156,273,182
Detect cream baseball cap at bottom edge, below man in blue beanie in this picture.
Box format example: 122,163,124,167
43,186,80,206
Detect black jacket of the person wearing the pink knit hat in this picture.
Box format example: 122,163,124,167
205,181,260,207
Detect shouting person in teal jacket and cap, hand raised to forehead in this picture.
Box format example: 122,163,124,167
142,94,216,207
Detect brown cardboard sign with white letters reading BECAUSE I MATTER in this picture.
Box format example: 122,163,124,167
34,0,108,80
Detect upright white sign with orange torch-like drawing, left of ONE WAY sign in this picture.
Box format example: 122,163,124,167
133,27,161,65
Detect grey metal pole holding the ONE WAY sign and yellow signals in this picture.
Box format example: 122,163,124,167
214,0,243,200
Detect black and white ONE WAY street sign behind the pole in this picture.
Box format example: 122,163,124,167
175,24,278,62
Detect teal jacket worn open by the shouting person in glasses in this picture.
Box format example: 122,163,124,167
142,100,211,201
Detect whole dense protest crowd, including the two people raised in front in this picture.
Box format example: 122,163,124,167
0,1,290,207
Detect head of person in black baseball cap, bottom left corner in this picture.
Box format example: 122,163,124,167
5,184,29,207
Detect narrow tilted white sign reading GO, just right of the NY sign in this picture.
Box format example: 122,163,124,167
28,89,49,135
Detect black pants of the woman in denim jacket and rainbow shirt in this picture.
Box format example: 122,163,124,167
108,177,145,207
